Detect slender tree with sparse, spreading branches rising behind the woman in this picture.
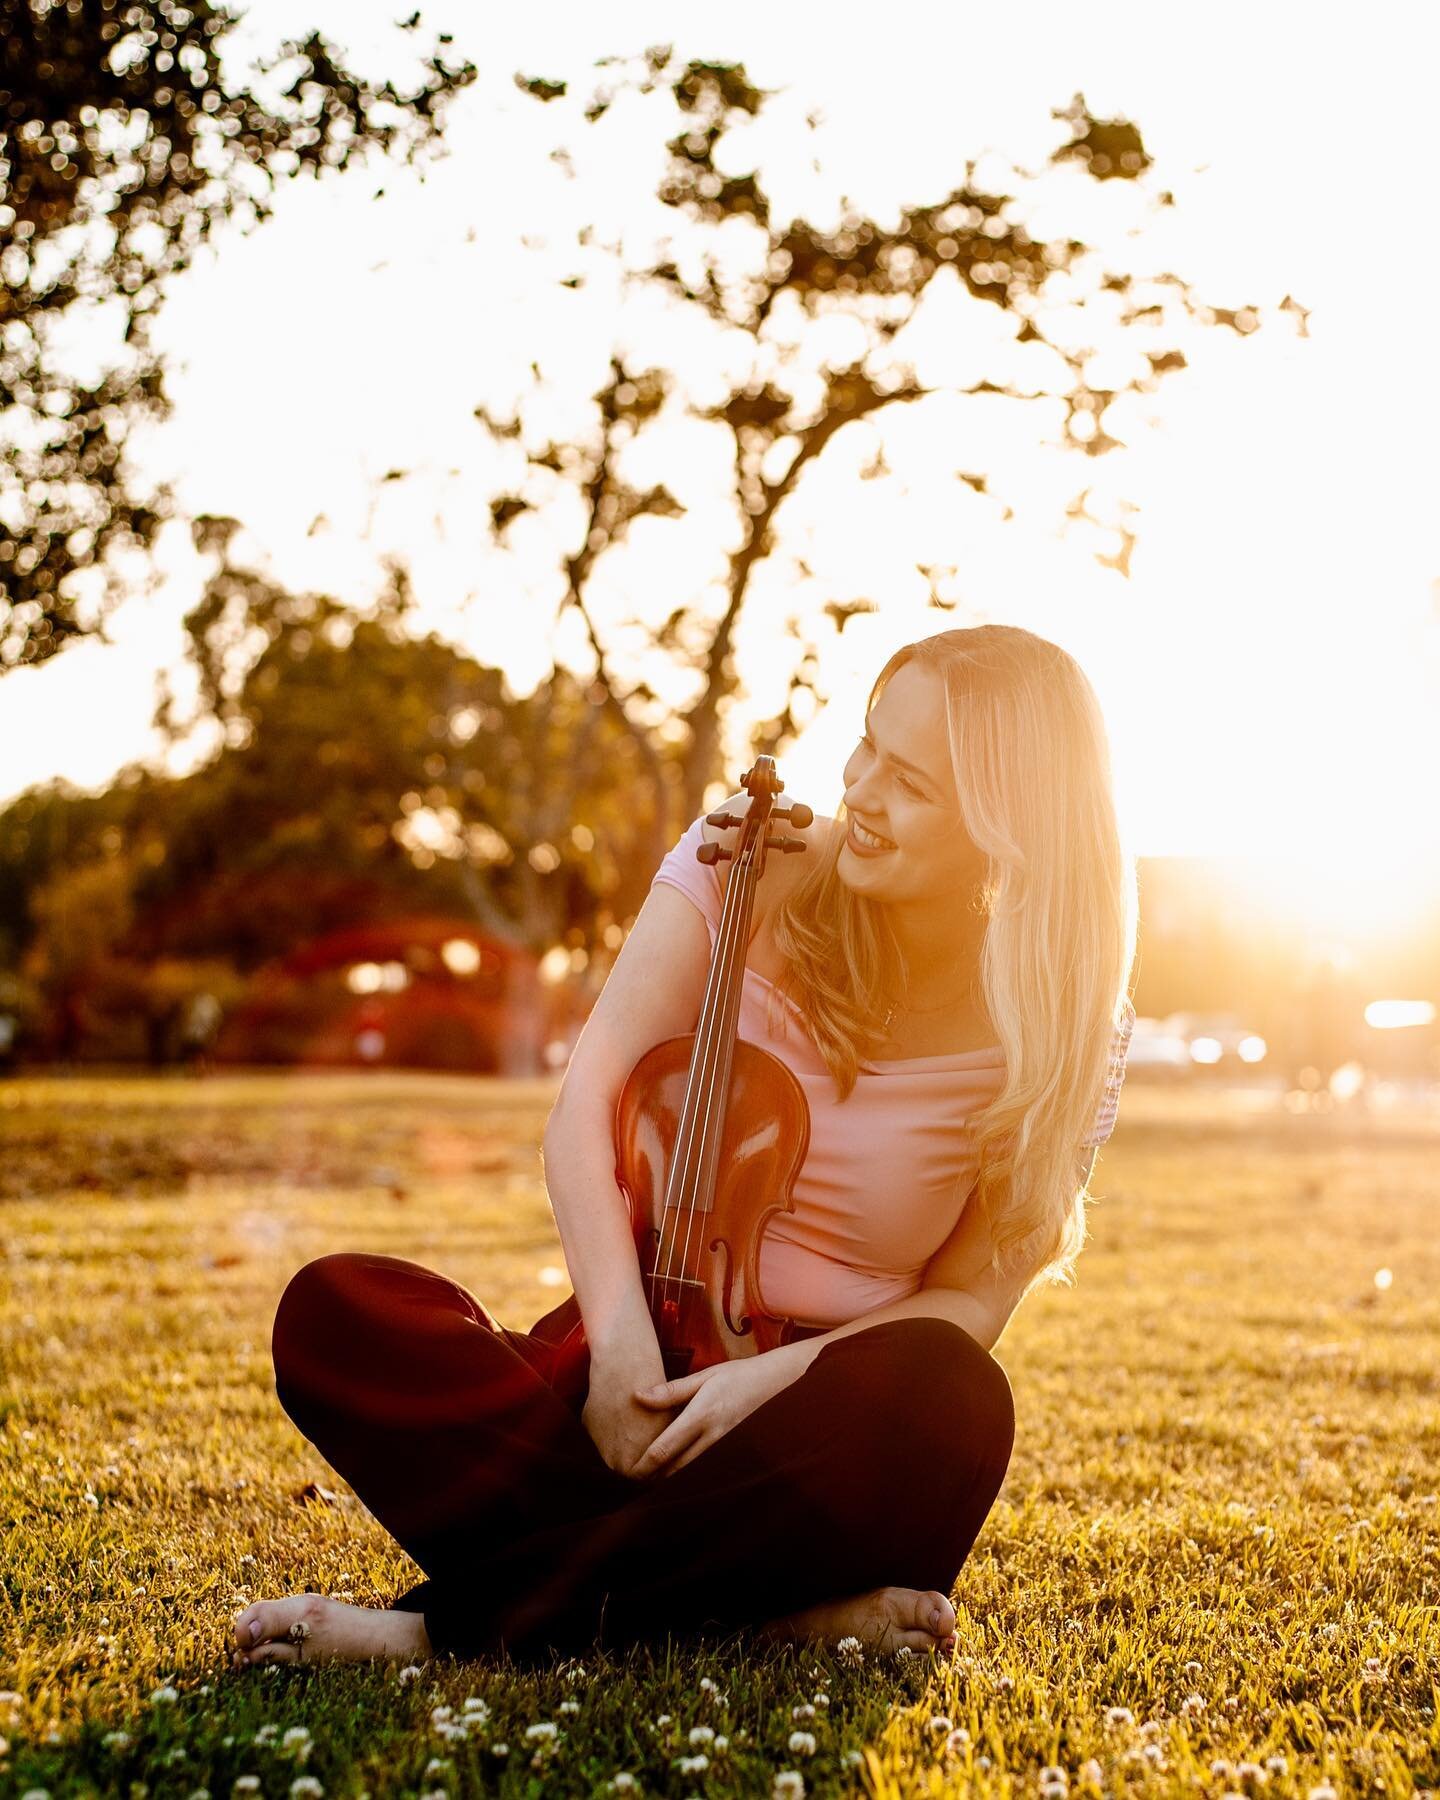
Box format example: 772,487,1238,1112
477,49,1300,835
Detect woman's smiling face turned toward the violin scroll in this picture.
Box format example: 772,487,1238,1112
835,661,985,905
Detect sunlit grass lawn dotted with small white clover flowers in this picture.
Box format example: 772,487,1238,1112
0,1076,1440,1800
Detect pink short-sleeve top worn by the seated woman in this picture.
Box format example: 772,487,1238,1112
655,819,1129,1327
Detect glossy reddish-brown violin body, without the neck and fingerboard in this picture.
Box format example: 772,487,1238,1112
616,1031,810,1379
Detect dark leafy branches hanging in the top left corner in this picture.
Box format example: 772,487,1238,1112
0,0,475,673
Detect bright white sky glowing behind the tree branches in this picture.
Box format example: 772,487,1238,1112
0,0,1440,907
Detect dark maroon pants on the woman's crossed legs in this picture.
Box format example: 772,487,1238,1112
272,1255,1015,1656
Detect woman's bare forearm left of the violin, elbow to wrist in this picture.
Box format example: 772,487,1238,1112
542,1100,655,1359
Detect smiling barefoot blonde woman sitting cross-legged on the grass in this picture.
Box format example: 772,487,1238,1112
236,625,1136,1663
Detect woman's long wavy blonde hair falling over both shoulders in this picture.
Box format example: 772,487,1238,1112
772,625,1138,1287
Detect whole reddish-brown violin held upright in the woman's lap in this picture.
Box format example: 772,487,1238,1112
529,756,814,1391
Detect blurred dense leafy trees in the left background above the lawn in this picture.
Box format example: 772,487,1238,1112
0,547,669,1028
